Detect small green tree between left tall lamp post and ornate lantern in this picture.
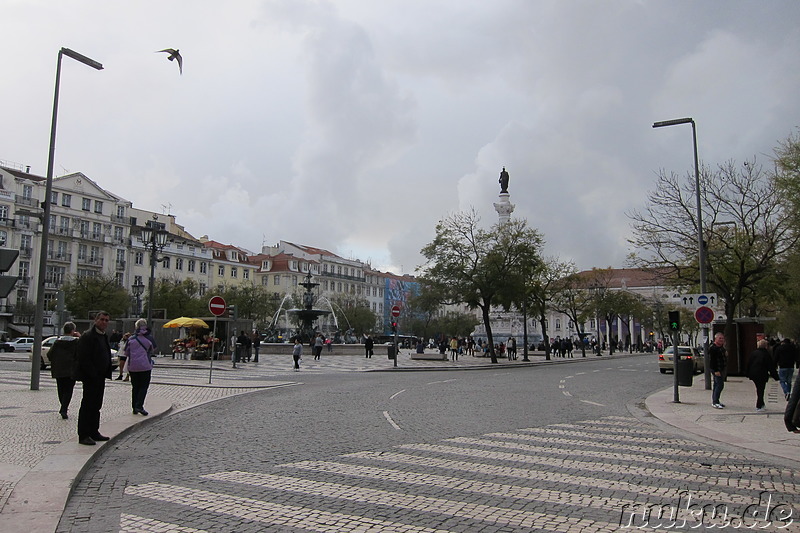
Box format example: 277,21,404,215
64,274,131,318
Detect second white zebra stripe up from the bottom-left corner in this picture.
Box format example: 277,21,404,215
125,482,447,533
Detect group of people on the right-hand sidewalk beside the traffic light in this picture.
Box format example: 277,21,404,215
708,333,800,433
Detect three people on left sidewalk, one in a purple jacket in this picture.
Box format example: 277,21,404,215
48,311,156,446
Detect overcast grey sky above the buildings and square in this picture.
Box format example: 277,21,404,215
0,0,800,273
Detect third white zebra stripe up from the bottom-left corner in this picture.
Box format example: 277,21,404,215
201,471,618,531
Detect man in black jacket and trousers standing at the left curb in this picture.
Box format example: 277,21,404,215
76,311,111,446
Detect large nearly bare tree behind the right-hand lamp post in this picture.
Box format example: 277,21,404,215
629,156,798,338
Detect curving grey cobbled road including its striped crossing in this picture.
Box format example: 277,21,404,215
58,356,800,532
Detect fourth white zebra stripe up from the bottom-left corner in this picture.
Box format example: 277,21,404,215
280,461,636,510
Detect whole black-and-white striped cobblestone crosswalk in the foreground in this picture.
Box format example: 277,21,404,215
119,417,800,533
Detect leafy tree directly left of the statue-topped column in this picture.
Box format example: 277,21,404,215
420,210,542,363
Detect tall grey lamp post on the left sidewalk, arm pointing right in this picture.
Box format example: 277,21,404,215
31,48,103,390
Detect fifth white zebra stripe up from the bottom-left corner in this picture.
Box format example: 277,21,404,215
350,451,768,504
